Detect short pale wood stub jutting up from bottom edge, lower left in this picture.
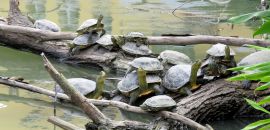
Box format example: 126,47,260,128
48,116,85,130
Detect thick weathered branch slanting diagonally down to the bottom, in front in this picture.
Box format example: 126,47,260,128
41,53,149,130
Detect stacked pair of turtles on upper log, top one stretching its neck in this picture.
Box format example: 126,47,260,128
69,15,106,55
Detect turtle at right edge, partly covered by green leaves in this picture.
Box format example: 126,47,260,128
237,50,270,89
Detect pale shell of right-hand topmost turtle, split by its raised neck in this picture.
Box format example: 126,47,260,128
206,43,235,56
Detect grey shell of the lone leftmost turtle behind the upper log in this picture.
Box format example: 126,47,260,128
34,19,61,32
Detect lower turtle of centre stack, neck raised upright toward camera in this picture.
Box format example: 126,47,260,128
117,68,162,104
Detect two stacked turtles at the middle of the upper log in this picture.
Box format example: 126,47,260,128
112,32,152,56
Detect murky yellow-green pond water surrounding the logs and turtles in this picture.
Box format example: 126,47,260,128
0,0,264,130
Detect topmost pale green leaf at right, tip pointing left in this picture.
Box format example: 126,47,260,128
228,10,270,24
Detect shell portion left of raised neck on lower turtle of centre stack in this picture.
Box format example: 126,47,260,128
117,71,139,95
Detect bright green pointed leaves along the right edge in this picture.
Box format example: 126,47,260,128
228,7,270,130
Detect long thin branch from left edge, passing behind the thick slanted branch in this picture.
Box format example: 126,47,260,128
0,77,209,129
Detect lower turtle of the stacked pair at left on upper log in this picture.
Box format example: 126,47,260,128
68,32,98,55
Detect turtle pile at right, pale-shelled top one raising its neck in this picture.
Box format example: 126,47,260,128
201,43,236,77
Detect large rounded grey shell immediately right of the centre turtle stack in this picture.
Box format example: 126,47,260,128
162,65,191,91
